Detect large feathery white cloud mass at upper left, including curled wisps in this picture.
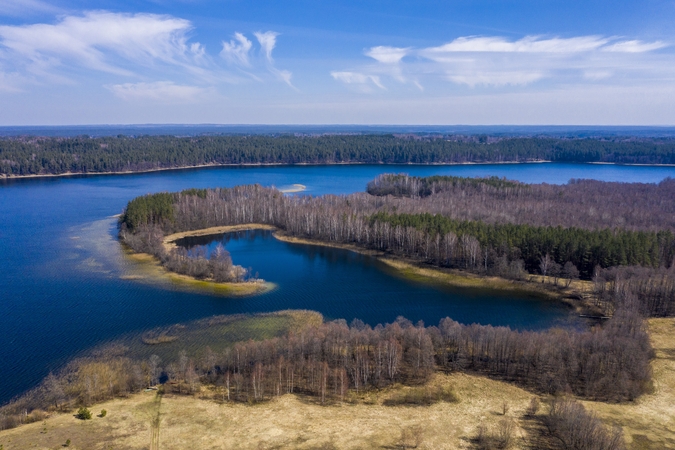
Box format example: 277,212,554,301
0,12,293,99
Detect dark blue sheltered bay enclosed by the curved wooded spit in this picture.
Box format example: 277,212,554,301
176,230,571,329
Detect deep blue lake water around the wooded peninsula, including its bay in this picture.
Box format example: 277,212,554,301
0,164,675,403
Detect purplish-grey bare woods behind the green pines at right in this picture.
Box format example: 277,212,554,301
368,174,675,231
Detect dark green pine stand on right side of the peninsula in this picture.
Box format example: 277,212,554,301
369,212,675,279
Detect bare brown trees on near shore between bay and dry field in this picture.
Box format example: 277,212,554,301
0,308,652,429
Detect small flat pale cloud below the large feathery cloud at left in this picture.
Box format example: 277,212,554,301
107,81,207,103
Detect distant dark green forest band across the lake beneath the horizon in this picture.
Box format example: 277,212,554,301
0,135,675,176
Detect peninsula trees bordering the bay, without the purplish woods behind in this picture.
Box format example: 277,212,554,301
120,185,675,315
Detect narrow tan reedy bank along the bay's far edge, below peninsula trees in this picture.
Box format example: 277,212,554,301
153,223,601,316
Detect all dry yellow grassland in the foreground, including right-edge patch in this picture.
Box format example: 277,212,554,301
0,319,675,450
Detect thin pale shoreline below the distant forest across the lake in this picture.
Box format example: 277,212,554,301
5,160,675,180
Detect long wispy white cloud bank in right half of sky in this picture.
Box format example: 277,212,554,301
331,35,668,89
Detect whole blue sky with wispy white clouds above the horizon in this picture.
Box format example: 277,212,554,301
0,0,675,126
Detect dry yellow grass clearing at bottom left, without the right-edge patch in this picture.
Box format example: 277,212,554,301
0,374,531,450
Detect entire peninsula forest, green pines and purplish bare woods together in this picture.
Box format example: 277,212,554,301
120,175,675,316
